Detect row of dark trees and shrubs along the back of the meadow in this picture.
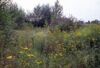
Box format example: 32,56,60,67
0,0,100,31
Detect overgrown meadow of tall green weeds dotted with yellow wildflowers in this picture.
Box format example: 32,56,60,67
0,24,100,68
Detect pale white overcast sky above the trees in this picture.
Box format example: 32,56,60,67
13,0,100,21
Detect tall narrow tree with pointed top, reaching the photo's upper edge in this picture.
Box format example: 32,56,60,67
51,0,63,26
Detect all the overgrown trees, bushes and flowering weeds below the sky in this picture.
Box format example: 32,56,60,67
0,0,100,68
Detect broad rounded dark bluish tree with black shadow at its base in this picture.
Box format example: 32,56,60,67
26,5,51,27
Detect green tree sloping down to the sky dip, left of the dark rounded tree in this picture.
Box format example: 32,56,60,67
8,4,25,29
